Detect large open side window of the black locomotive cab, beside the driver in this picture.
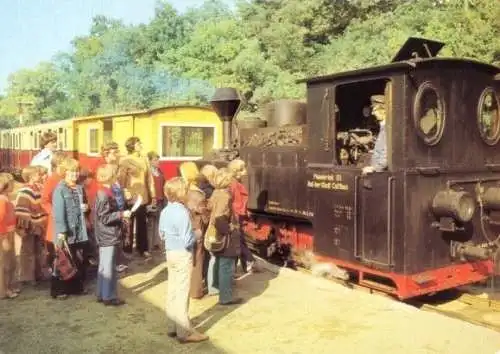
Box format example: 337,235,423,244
335,78,392,167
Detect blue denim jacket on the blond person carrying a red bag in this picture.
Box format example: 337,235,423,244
52,180,88,245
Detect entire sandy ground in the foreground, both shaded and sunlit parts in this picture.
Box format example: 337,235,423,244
0,250,500,354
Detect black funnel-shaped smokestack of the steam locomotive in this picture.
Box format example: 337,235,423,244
210,87,241,150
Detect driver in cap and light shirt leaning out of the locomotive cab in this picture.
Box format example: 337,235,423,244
363,95,387,175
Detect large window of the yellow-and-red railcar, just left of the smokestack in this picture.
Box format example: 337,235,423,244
161,126,214,157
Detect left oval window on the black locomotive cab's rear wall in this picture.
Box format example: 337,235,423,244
413,82,445,146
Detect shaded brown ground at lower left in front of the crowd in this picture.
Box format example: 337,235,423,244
0,254,229,354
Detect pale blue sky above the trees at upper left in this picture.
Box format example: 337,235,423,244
0,0,223,93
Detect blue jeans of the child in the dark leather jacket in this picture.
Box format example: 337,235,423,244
97,246,118,300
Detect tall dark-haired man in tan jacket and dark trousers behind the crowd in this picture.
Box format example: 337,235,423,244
119,136,156,258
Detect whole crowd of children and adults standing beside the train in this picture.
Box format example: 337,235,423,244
0,131,254,342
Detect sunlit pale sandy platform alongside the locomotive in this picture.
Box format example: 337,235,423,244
121,263,500,354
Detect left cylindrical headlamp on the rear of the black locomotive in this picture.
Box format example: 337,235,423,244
432,189,476,223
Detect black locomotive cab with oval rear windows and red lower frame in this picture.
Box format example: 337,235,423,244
306,38,500,298
